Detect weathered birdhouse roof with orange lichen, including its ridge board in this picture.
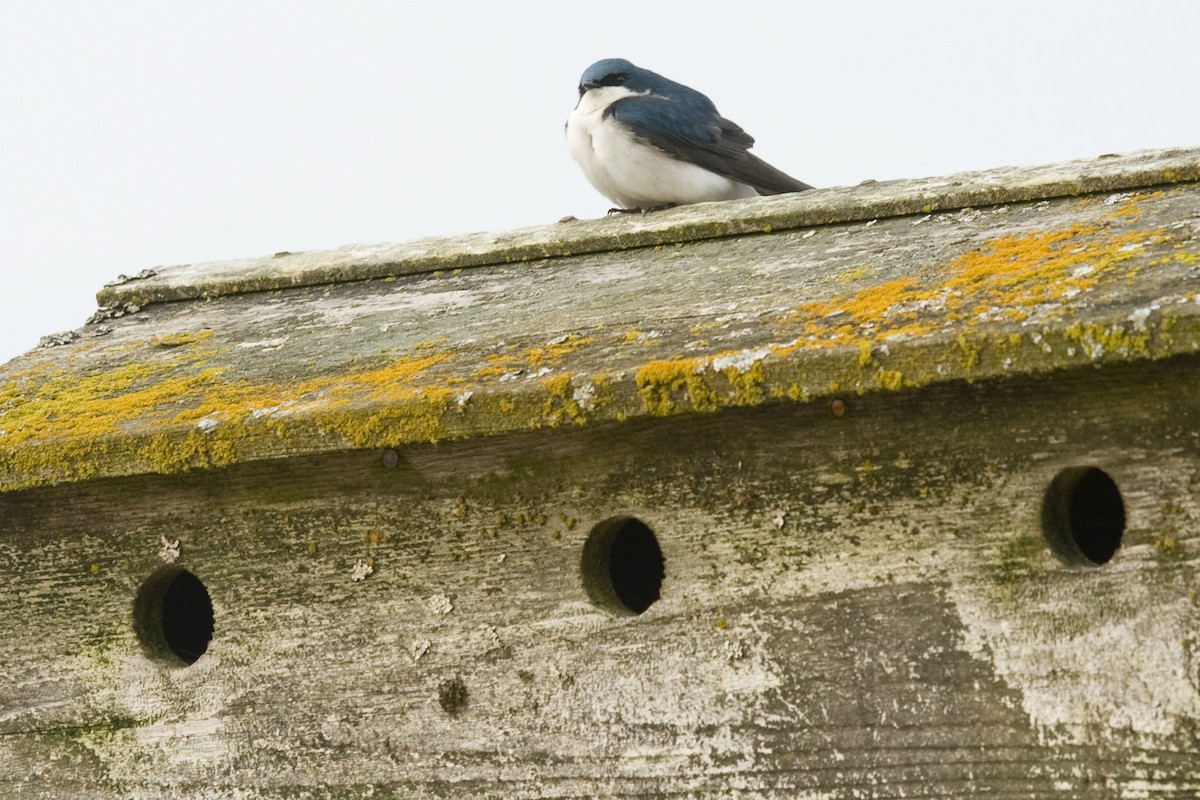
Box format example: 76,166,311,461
0,149,1200,491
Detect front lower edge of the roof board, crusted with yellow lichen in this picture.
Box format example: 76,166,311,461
0,303,1200,495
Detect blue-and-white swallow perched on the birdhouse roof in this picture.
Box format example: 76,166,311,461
565,59,812,213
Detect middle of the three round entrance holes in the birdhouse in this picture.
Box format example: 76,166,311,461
581,517,665,614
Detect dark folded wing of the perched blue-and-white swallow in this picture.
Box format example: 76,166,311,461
605,95,812,194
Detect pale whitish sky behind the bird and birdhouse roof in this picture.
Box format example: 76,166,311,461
0,0,1200,362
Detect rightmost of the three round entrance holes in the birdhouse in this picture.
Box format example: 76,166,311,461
1042,467,1126,566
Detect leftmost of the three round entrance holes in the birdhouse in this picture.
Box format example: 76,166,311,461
133,565,212,666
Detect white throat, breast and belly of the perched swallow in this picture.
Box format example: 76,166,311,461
566,86,757,209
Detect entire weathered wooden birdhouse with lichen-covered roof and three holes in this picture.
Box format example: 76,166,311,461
0,150,1200,800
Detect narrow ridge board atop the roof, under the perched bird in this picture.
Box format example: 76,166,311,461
96,148,1200,308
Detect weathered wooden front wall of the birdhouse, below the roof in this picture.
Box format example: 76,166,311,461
0,357,1200,799
